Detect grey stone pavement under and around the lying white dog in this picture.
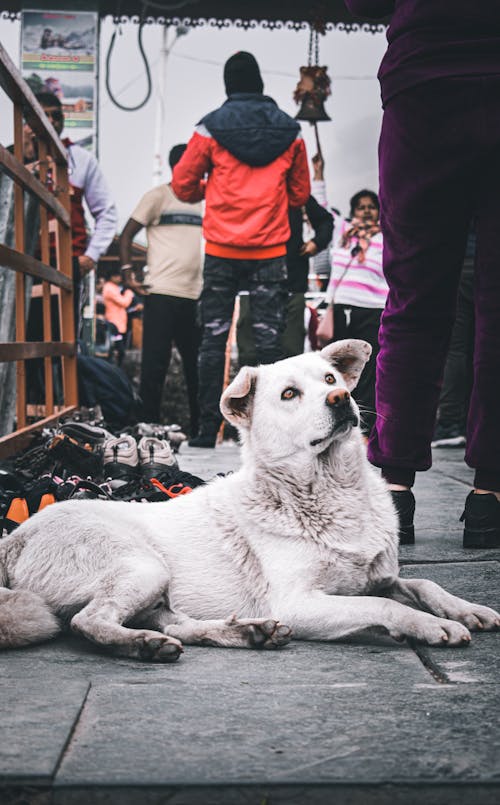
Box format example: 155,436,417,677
0,444,500,805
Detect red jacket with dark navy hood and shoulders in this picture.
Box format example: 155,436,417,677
172,93,311,259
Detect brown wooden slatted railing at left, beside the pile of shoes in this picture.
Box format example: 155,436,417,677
0,45,78,457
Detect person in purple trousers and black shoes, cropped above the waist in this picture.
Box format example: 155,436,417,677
346,0,500,548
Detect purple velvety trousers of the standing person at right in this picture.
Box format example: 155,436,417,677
368,76,500,491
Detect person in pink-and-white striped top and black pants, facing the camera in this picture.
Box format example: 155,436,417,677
325,190,388,435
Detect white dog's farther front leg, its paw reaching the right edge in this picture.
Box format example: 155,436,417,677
381,578,500,630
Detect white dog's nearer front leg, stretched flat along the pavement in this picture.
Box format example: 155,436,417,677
278,590,470,646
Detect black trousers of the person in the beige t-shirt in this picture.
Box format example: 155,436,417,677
140,294,200,435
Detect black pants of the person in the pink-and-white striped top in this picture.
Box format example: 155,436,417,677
334,305,382,435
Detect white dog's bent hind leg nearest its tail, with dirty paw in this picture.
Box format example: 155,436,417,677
71,555,182,662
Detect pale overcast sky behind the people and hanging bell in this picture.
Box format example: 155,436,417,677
0,17,386,227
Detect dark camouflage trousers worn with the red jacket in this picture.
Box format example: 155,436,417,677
199,254,287,435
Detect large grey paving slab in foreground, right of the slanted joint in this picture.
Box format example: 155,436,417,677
52,679,500,790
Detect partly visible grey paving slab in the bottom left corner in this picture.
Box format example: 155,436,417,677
0,680,90,786
